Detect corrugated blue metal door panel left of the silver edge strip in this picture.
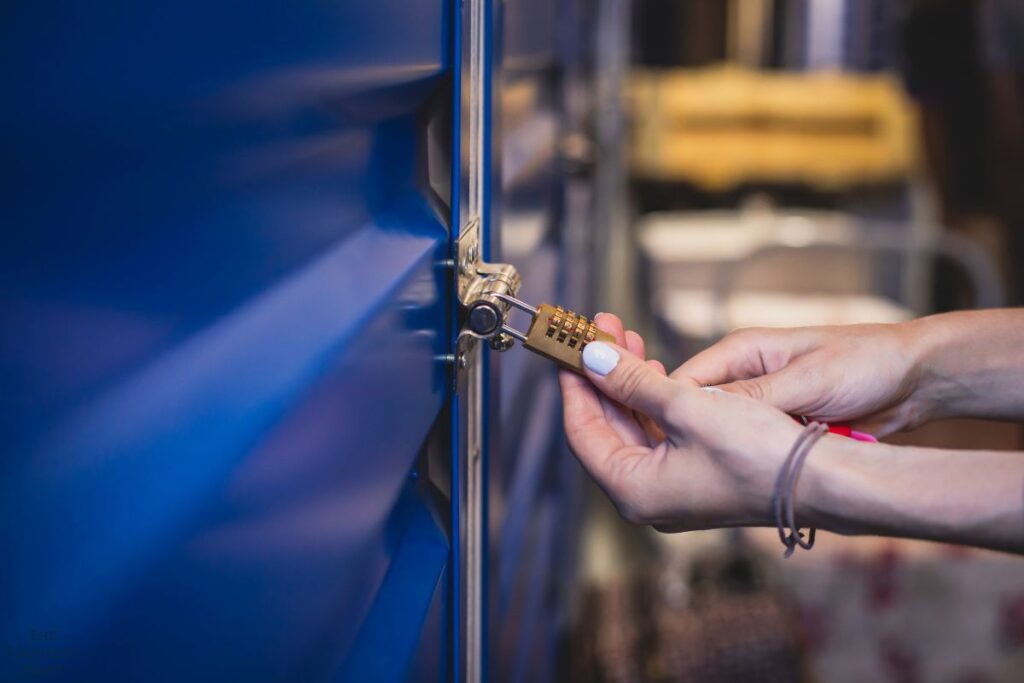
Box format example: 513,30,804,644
0,0,450,681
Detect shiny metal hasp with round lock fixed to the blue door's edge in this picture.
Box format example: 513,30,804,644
457,217,525,352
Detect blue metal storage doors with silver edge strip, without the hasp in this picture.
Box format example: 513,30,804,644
0,0,590,681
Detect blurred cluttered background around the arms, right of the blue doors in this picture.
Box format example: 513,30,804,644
569,0,1024,683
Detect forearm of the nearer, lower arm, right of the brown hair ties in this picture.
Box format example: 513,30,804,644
797,437,1024,553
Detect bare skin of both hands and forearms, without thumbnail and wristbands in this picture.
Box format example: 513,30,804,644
560,310,1024,553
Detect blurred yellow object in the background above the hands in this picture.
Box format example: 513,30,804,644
628,66,915,190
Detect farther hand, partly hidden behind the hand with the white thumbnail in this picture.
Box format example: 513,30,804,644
672,324,929,436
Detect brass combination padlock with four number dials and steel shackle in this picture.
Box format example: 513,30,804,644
471,294,615,374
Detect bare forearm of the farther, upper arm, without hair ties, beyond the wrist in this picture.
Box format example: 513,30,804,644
904,309,1024,420
